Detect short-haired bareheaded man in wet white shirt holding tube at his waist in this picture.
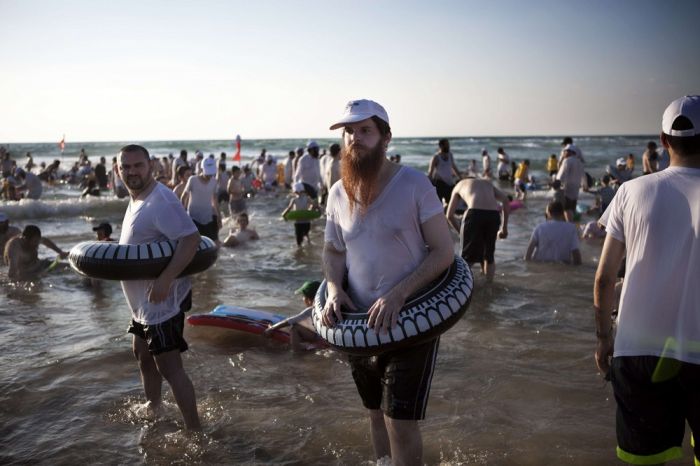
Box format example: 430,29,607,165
118,144,200,430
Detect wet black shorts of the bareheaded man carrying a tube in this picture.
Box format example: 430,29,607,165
127,291,192,354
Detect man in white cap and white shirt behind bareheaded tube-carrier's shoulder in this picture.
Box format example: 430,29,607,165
181,157,221,244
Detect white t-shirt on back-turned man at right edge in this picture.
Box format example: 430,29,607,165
605,167,700,364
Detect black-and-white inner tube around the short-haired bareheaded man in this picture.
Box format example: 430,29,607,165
68,236,218,280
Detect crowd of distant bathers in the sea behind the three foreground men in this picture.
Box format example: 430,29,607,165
0,137,669,279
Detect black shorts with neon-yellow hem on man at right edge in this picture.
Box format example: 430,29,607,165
610,356,700,464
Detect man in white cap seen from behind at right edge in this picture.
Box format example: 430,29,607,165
593,96,700,464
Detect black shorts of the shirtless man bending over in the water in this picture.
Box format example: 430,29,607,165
459,209,501,264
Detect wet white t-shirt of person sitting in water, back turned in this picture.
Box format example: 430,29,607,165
530,220,579,263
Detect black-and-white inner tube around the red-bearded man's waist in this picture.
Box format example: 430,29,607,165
312,256,474,355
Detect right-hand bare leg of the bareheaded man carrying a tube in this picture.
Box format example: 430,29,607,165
154,350,201,430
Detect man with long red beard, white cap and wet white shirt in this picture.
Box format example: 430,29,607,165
323,100,454,464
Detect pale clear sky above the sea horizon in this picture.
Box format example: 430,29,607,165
0,0,700,142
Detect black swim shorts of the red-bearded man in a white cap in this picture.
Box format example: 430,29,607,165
348,337,440,420
